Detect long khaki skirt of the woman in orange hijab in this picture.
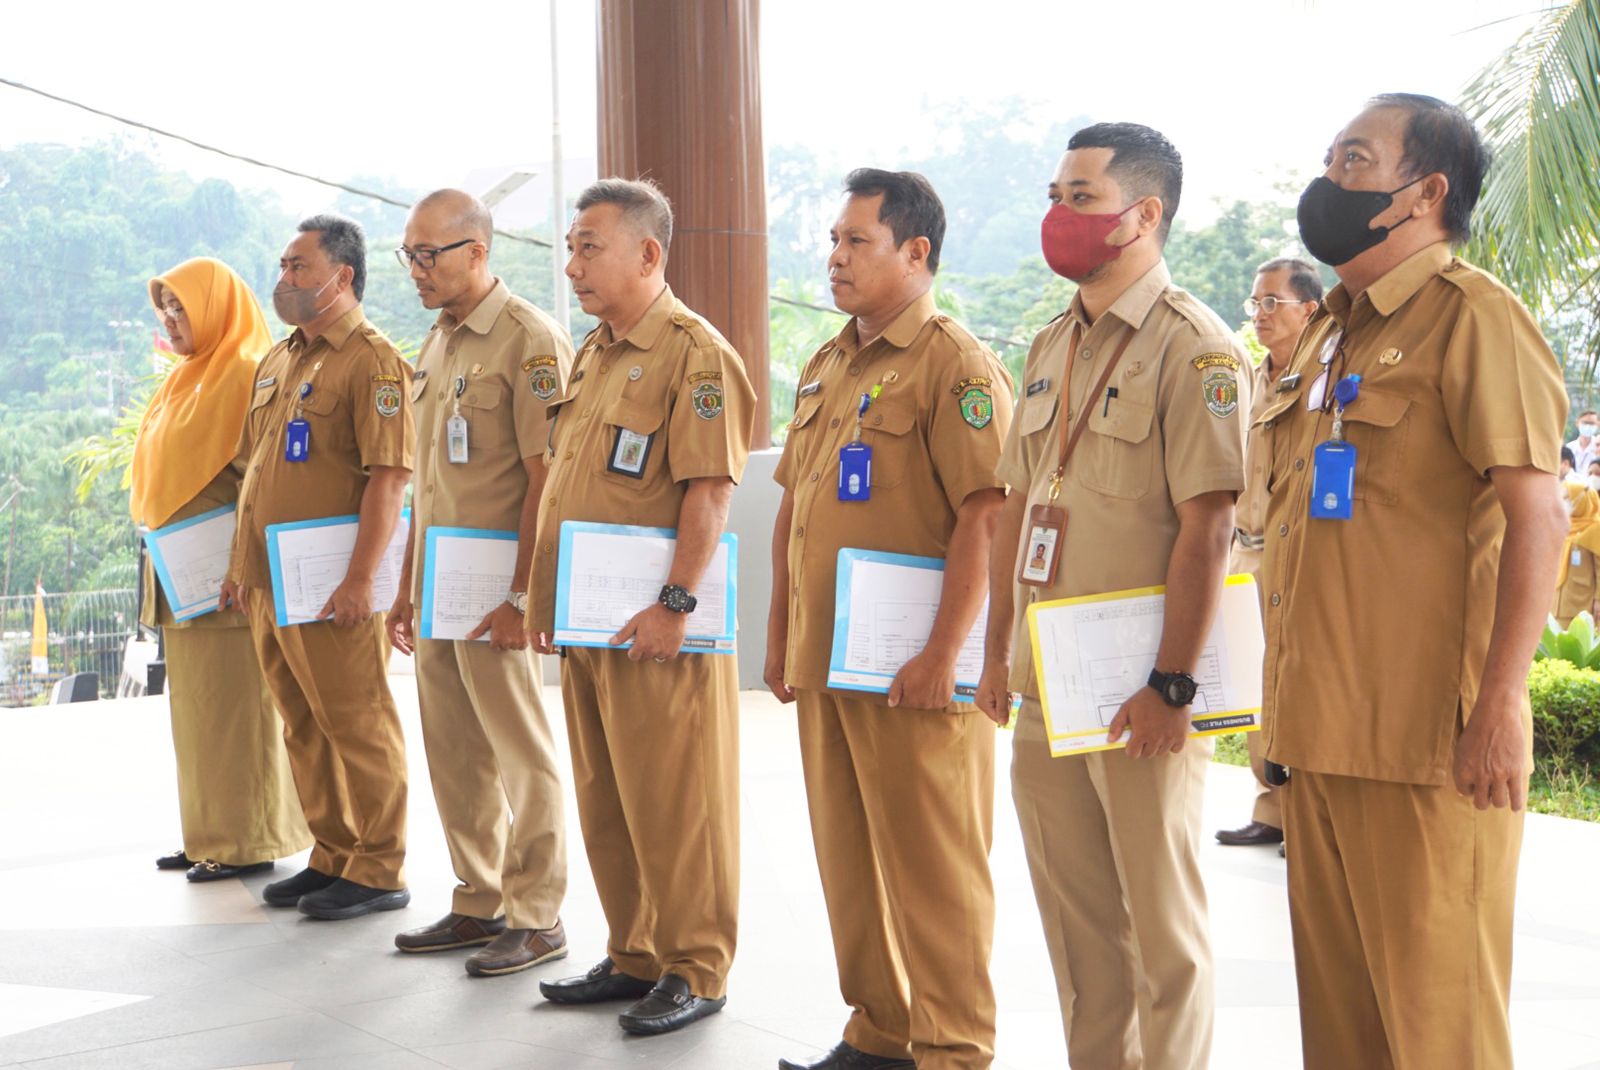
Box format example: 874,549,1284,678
163,627,312,865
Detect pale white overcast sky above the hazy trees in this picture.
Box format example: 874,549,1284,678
0,0,1542,230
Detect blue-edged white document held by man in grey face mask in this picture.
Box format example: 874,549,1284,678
267,510,411,627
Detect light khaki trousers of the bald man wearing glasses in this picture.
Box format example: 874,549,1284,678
416,640,566,929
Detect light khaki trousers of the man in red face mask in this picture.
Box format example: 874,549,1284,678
1011,697,1216,1070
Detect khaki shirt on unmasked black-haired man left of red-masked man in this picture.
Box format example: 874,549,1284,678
776,294,1013,689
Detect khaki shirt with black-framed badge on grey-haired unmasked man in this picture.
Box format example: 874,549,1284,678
528,286,755,632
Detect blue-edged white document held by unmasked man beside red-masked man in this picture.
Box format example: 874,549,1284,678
827,547,989,702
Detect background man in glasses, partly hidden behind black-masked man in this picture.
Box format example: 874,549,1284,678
1216,259,1322,851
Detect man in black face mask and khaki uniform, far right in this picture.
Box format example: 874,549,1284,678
1256,94,1568,1070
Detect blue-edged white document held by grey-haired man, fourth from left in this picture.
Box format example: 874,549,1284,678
554,520,738,654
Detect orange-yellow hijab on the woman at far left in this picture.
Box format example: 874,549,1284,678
128,256,272,528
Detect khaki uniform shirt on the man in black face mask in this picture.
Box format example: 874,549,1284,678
1256,242,1566,784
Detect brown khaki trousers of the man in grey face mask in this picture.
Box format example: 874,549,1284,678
246,589,406,889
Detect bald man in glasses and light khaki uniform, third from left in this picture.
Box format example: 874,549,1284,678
387,189,573,977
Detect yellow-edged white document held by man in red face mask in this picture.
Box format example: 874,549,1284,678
1027,576,1266,757
